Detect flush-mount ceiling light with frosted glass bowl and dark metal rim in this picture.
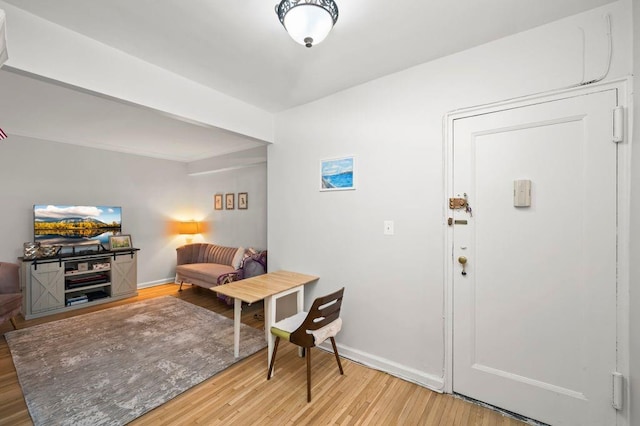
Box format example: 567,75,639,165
276,0,338,47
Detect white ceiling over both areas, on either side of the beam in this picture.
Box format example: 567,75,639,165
0,0,613,161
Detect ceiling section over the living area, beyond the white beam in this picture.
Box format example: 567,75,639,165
0,68,266,162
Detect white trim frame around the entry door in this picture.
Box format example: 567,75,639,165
442,77,633,426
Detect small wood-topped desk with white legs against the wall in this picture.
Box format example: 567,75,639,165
211,271,319,368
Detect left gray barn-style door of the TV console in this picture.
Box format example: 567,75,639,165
27,262,64,314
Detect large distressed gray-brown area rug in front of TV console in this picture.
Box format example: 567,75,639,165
5,296,266,425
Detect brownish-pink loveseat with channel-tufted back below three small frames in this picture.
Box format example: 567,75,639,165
176,243,267,303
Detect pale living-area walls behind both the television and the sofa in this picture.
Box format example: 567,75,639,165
0,136,266,286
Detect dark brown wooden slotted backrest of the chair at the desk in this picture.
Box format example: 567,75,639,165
289,287,344,348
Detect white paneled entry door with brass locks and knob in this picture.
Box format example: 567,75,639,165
452,89,617,426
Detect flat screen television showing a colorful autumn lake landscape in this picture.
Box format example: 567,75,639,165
33,204,122,246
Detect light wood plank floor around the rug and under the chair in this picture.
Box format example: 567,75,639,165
0,284,525,426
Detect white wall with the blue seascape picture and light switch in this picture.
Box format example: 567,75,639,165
268,0,631,388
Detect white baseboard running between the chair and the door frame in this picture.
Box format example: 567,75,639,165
319,341,444,393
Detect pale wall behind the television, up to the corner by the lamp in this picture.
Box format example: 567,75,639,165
0,136,190,283
